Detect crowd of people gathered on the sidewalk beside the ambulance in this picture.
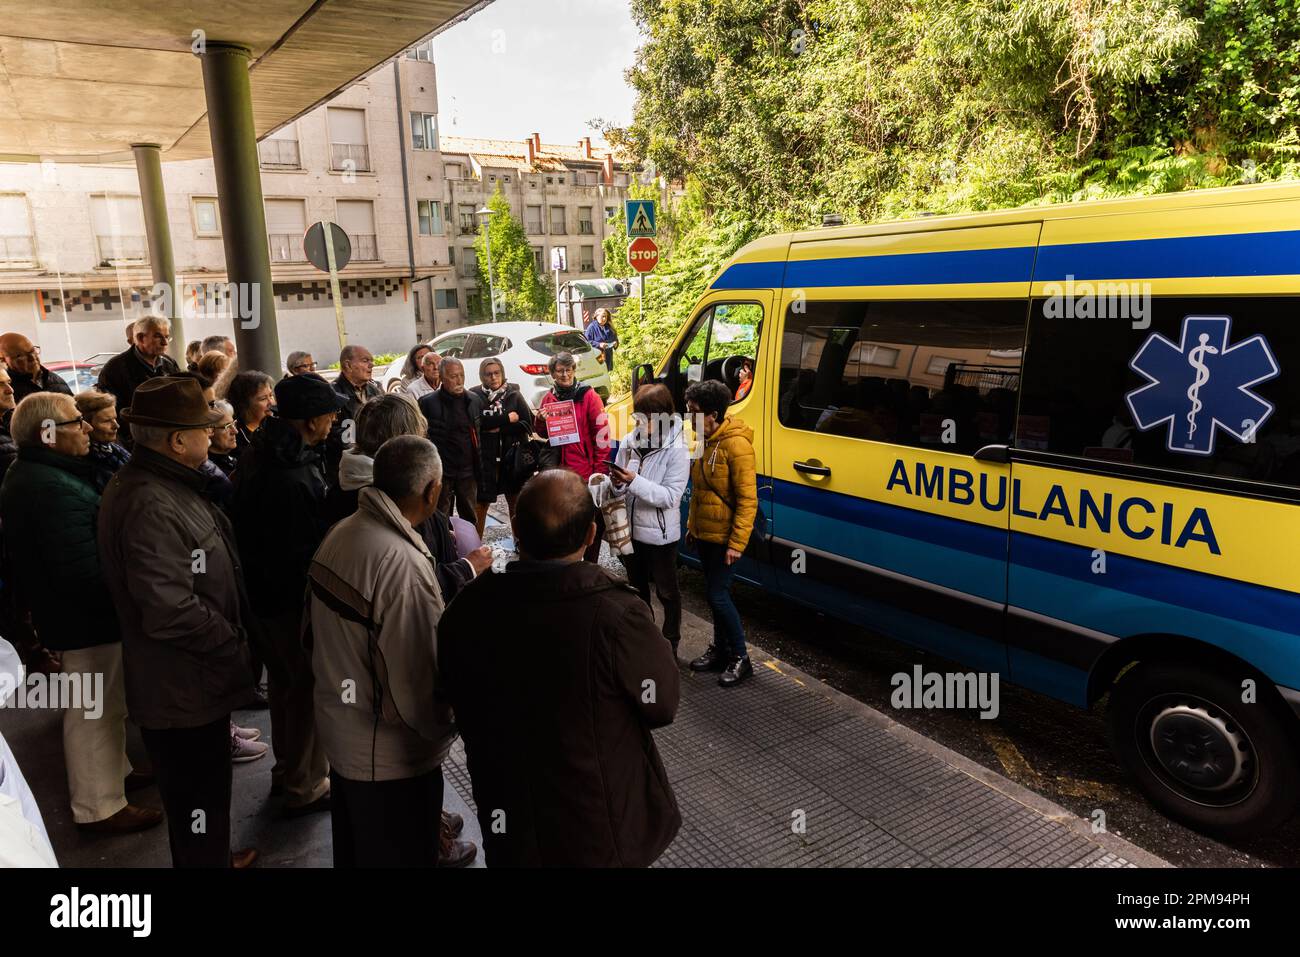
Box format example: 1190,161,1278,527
0,316,758,867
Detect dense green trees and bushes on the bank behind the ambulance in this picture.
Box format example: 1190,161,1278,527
606,0,1300,384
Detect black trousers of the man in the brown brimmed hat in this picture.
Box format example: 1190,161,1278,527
140,715,230,867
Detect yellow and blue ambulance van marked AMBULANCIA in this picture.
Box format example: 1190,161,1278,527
611,185,1300,836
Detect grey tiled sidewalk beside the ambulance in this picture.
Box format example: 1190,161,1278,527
445,612,1169,867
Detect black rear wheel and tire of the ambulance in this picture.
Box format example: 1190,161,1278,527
1106,659,1300,840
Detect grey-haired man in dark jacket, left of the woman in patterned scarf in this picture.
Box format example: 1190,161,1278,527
420,358,484,527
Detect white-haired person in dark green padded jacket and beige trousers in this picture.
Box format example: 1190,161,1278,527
0,393,163,833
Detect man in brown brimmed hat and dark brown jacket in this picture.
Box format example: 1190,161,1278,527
99,374,257,867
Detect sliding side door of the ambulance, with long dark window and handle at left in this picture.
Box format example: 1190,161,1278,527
770,222,1039,672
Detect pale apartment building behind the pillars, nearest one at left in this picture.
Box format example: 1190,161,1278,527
0,40,464,361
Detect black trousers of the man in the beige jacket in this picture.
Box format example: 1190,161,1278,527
329,766,442,867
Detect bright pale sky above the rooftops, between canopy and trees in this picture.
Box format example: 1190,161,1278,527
434,0,640,143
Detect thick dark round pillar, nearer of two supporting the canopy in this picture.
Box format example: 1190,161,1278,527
202,40,281,376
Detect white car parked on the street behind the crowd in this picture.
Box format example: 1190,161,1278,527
374,322,610,408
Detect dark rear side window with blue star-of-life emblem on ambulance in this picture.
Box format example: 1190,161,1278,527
1015,296,1300,486
